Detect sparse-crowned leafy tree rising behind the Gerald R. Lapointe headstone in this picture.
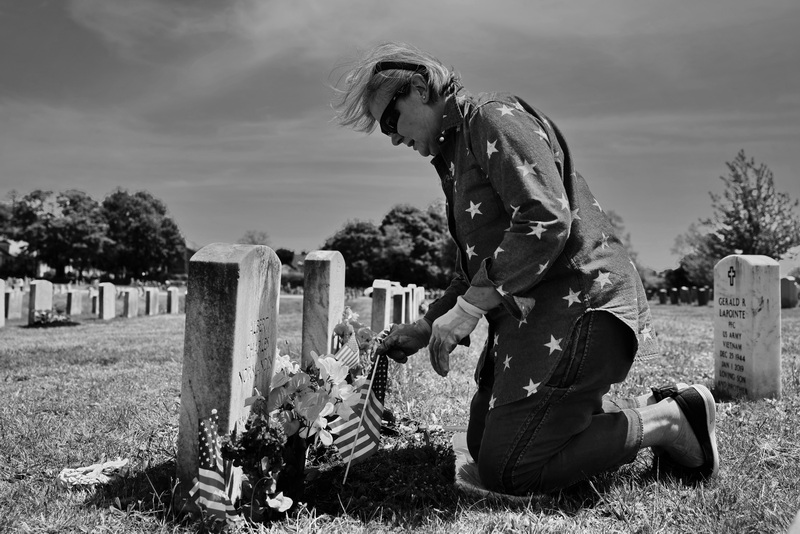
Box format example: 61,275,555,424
673,150,800,285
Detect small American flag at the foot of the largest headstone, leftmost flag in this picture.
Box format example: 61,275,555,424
189,410,236,521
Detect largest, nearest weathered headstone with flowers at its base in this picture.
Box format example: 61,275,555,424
177,243,281,509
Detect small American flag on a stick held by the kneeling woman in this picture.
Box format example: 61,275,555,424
331,355,389,469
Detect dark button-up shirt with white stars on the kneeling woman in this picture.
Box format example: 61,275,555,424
425,86,657,409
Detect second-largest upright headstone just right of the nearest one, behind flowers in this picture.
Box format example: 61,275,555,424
301,250,345,368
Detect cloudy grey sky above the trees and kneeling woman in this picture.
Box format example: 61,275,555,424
0,0,800,269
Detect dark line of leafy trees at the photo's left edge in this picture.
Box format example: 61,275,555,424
0,188,186,280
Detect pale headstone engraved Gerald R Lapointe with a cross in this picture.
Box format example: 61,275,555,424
714,255,781,399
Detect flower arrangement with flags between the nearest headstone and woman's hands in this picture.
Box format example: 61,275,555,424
211,308,387,522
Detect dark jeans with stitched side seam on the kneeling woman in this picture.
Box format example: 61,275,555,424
467,311,642,495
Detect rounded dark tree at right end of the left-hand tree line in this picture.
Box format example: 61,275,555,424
103,189,186,278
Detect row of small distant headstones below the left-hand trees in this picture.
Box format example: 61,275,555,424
0,279,180,327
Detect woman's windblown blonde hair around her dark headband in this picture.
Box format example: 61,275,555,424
332,42,459,133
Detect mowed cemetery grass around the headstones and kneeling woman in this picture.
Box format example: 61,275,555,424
0,297,800,533
